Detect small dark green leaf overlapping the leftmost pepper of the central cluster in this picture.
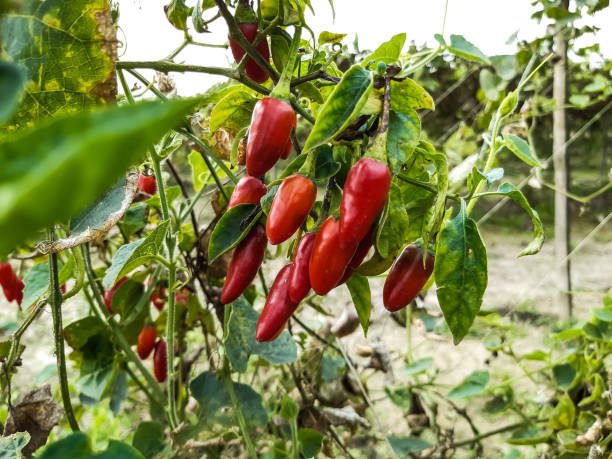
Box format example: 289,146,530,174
208,204,261,263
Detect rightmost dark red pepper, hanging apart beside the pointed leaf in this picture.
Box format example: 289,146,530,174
383,244,434,312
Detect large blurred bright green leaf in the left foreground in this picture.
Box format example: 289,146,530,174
0,99,197,253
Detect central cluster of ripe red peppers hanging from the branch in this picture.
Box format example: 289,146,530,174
221,8,433,341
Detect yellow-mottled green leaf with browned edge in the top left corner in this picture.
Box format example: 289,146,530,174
0,0,116,131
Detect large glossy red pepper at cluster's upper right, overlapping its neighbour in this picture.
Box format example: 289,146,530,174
340,158,391,252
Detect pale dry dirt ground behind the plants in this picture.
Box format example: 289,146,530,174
0,223,612,457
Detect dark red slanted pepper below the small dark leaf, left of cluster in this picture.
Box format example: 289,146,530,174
221,225,268,304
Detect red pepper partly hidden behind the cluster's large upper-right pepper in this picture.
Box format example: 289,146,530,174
308,217,357,295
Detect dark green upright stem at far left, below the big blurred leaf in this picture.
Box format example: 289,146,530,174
49,229,80,432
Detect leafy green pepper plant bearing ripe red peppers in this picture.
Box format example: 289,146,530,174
0,0,596,458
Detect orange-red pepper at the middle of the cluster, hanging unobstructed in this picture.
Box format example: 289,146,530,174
266,174,317,245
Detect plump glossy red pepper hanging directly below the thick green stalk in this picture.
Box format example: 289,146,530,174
246,97,297,177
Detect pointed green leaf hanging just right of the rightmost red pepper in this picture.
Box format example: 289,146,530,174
434,201,487,344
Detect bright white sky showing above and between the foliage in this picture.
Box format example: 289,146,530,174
119,0,612,95
